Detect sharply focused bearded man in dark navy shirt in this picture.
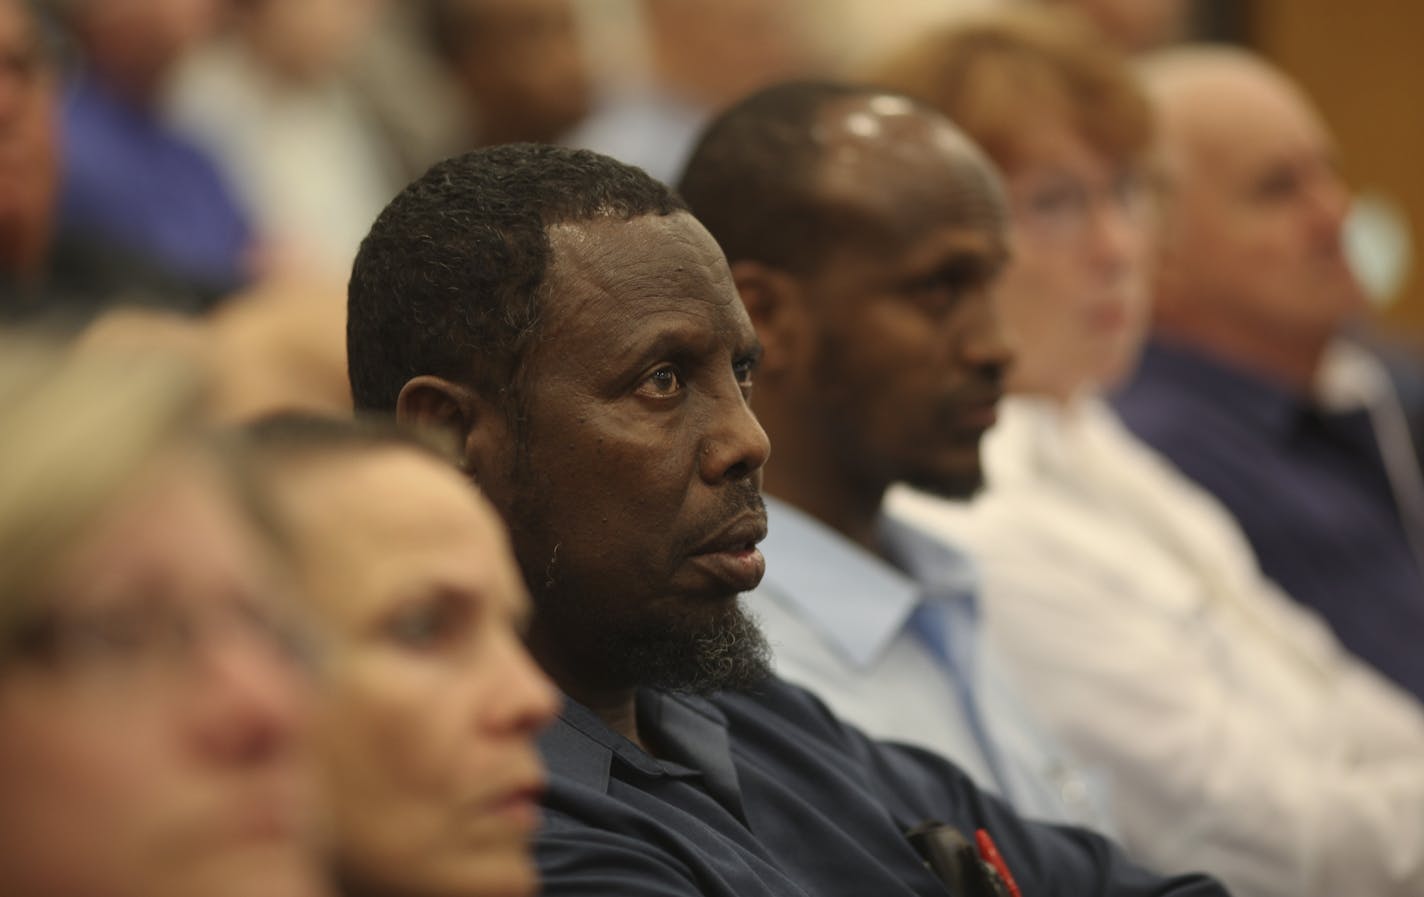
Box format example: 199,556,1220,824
347,145,1222,897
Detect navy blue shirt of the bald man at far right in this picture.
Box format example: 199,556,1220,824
1115,337,1424,698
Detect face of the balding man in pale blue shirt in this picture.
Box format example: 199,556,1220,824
796,97,1011,495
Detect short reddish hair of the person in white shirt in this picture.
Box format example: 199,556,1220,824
866,7,1153,171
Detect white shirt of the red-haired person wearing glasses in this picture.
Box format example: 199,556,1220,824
889,399,1424,897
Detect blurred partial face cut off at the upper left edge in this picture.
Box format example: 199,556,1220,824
0,0,60,273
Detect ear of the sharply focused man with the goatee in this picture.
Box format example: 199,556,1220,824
396,374,508,483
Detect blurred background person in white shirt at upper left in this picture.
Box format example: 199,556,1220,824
167,0,403,279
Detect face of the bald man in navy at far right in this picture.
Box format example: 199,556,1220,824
1159,70,1364,351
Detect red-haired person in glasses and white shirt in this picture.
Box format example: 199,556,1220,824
877,14,1424,897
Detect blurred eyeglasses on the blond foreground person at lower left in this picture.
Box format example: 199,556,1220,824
0,599,315,691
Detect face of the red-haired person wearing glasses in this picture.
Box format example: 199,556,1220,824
998,121,1152,399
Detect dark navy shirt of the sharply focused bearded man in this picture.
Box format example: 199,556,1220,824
535,679,1225,897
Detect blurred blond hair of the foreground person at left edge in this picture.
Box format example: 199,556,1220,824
0,333,204,659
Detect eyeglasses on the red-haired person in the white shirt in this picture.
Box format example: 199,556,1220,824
1012,169,1158,242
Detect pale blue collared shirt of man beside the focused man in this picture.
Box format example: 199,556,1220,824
748,498,1111,833
